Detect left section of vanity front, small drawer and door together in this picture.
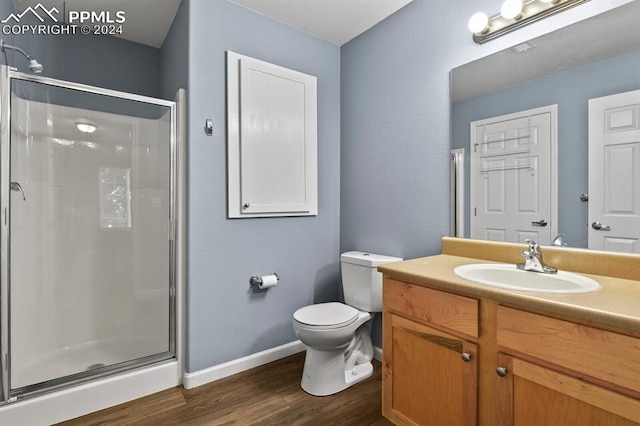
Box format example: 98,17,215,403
382,278,478,425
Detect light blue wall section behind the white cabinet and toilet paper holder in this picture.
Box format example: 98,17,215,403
186,0,340,372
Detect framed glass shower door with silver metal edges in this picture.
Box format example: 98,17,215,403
0,69,175,400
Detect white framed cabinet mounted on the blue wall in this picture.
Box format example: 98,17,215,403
227,51,318,218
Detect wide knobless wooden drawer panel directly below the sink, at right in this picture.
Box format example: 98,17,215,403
498,306,640,392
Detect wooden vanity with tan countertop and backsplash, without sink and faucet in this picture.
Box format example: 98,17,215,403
379,238,640,425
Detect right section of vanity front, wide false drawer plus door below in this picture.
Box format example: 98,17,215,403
496,306,640,426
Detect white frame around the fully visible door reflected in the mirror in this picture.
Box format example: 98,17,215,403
469,104,558,245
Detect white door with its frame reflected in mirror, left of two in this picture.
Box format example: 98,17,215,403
470,105,557,245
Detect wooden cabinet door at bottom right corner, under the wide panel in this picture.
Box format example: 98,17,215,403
497,354,640,426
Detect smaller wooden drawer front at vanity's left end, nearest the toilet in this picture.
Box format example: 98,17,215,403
383,278,478,337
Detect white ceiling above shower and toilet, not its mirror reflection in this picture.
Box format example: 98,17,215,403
13,0,412,48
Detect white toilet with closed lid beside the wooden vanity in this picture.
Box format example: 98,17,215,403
293,251,402,396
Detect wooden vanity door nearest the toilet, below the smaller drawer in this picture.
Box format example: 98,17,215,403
382,313,477,425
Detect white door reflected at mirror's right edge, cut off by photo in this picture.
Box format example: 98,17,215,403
589,90,640,253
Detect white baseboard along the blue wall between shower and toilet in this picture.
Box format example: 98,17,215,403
182,340,307,389
